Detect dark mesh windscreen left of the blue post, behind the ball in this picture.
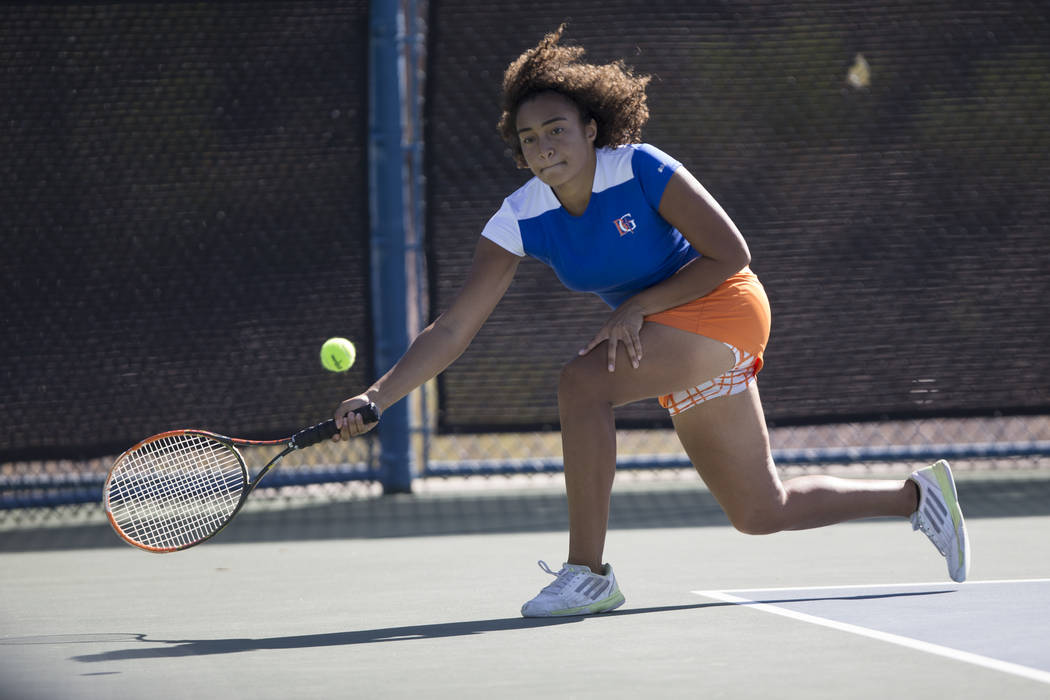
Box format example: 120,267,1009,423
0,1,373,460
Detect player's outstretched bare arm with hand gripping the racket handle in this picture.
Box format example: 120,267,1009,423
335,237,521,440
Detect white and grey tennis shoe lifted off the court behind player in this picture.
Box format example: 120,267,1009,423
910,460,970,584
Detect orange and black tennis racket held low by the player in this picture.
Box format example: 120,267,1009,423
102,403,379,552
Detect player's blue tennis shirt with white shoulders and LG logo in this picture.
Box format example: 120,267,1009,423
482,144,699,309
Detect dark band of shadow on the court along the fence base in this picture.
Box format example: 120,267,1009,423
6,478,1050,552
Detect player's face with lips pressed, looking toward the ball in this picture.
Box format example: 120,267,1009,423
517,92,597,192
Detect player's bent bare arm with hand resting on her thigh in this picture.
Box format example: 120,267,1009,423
580,167,751,372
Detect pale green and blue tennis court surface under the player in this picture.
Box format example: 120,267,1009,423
0,474,1050,700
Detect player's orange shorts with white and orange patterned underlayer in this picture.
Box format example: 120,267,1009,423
646,268,771,416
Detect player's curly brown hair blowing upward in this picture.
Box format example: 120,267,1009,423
499,24,650,166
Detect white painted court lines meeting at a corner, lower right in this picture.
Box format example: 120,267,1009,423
693,578,1050,683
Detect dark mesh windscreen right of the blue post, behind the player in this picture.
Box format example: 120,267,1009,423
427,0,1050,432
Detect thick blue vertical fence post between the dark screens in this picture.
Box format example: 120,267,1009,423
369,0,412,493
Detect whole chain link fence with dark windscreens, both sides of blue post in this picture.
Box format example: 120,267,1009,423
0,0,1050,522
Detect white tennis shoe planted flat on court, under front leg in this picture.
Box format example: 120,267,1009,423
522,561,624,617
